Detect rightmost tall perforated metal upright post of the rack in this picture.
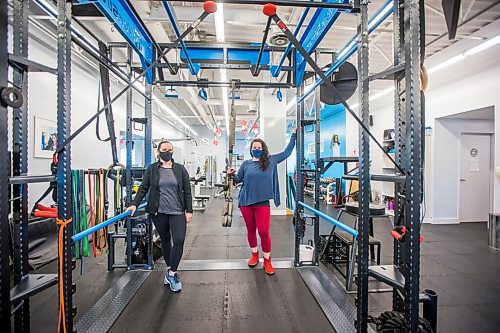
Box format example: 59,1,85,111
400,0,422,333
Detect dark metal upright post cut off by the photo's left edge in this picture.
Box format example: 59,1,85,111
0,1,11,326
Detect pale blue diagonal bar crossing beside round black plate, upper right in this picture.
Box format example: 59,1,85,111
297,0,394,104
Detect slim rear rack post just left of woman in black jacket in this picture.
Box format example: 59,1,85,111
125,46,133,269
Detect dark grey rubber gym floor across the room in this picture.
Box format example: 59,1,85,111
30,193,500,333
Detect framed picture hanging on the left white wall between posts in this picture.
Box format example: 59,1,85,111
33,117,57,158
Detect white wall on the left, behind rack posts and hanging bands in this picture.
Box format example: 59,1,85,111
13,24,192,207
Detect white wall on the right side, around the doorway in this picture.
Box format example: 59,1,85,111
347,21,500,223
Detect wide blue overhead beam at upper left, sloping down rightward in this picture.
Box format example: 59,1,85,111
77,0,153,84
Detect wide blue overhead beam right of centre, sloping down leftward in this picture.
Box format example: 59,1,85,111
295,0,349,86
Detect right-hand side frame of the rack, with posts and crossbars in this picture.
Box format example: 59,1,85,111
286,0,437,332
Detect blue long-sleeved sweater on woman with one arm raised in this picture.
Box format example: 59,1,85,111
234,134,296,207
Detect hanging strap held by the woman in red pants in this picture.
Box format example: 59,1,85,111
222,80,236,227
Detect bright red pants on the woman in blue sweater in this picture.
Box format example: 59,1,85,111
240,206,271,252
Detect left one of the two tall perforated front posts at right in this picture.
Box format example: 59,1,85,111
356,0,371,333
